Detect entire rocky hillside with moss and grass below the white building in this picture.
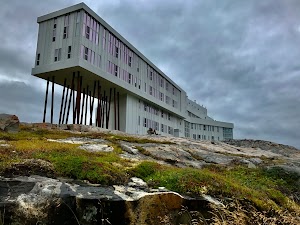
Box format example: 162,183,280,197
0,124,300,225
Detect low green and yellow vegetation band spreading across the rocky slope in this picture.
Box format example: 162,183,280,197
0,128,300,224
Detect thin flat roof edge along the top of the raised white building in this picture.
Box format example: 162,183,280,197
37,2,186,93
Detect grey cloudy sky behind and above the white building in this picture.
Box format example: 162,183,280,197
0,0,300,148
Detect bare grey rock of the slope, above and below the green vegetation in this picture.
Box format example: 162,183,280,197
0,124,300,225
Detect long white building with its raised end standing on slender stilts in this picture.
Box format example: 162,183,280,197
32,3,233,140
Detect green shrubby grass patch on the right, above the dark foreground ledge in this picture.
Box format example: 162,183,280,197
131,162,300,214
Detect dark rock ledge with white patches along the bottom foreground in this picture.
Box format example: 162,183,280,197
0,176,223,225
